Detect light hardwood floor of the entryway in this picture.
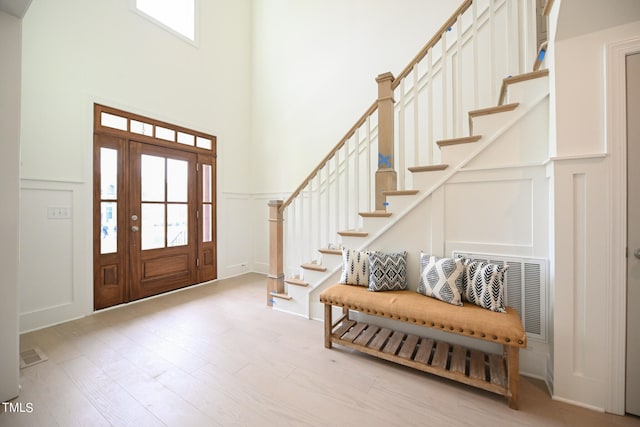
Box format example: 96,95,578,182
0,274,640,427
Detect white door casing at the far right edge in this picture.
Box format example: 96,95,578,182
605,37,640,415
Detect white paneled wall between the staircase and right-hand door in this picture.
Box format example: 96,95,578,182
550,0,640,410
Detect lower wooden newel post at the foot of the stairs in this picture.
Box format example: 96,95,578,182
267,200,284,307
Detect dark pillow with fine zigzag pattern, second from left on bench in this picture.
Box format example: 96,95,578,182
369,251,407,292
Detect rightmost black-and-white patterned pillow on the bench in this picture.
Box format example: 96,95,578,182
463,261,509,313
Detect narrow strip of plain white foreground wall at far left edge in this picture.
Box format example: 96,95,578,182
0,11,22,402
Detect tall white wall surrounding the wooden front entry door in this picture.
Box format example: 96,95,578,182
20,0,251,331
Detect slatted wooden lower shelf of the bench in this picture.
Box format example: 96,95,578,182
331,320,509,396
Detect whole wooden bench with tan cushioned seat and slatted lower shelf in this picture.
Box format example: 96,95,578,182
320,284,527,409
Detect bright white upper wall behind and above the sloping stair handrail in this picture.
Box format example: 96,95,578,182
252,0,461,193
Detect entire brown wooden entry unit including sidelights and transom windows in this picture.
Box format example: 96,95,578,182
94,106,217,309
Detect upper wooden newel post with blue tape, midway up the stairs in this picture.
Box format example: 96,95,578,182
376,73,398,211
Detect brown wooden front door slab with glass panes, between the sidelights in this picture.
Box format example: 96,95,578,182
127,141,197,300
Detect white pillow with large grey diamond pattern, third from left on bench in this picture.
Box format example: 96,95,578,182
418,253,465,305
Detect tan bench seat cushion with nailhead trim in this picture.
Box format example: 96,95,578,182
320,284,527,348
